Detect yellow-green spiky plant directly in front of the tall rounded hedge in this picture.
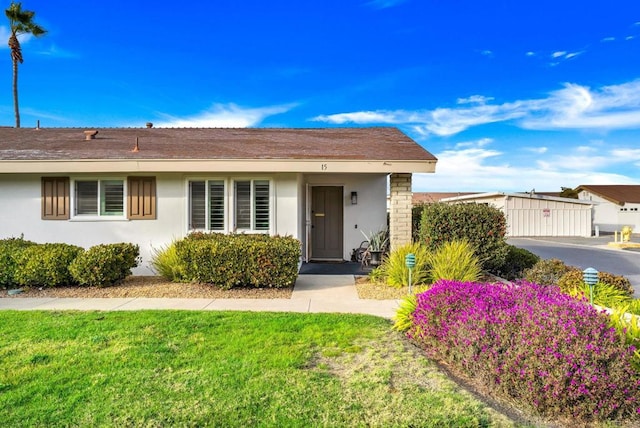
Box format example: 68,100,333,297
427,240,482,282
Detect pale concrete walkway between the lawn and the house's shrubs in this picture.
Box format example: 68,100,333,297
0,275,398,318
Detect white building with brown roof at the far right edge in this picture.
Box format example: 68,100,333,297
576,184,640,232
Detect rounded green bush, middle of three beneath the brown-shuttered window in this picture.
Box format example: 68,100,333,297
15,244,83,287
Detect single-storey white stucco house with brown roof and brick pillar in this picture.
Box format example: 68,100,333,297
0,124,436,275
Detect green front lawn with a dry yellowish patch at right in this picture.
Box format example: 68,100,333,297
0,311,515,427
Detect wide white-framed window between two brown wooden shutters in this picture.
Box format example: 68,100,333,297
75,180,124,217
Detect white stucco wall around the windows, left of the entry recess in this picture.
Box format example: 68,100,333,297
0,174,300,275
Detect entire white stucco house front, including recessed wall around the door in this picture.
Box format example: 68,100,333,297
0,173,387,275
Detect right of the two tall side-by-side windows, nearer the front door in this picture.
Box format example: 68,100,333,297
234,180,270,231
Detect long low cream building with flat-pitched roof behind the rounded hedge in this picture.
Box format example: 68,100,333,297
441,191,593,237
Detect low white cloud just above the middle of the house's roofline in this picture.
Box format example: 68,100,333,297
154,103,295,128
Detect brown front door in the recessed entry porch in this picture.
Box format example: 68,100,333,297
311,186,343,260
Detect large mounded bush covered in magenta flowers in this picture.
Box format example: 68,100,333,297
407,280,640,421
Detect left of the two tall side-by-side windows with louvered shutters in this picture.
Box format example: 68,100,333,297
189,180,226,231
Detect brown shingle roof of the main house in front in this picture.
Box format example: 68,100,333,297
0,127,436,162
